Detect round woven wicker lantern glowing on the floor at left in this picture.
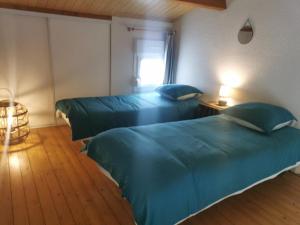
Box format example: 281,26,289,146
0,100,30,144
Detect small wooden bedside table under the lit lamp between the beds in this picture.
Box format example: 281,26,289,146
197,101,229,118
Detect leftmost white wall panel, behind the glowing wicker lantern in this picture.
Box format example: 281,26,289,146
0,14,54,126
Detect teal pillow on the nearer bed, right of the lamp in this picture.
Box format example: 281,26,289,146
222,102,297,134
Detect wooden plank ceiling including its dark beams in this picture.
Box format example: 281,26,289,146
0,0,226,21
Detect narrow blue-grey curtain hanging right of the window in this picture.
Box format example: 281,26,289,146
164,32,176,84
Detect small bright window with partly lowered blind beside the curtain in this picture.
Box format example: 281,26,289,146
135,40,165,91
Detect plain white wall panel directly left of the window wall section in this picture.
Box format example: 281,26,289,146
49,18,110,100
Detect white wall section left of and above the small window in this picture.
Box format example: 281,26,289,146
111,17,172,95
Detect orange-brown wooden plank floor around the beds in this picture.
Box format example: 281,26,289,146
0,127,300,225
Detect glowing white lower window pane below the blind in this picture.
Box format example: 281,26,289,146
138,58,165,86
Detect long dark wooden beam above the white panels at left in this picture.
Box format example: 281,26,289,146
0,3,112,20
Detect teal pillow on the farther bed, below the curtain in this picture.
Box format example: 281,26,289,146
155,84,203,100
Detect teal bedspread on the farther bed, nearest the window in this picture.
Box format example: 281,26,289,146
56,92,198,140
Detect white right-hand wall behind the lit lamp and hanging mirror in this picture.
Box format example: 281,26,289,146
176,0,300,118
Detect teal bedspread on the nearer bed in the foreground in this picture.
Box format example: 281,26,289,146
87,116,300,225
